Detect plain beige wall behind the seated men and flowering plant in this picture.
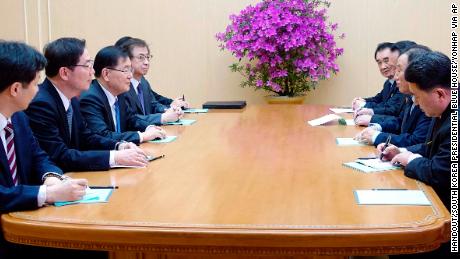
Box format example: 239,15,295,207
0,0,452,106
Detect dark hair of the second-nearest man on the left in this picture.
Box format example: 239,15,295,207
43,38,86,77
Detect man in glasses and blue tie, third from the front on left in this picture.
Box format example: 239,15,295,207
80,46,165,144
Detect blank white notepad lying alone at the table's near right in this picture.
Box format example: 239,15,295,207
354,189,431,206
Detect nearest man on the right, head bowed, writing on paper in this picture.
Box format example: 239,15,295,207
377,52,451,258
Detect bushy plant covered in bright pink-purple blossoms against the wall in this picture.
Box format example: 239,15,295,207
216,0,344,96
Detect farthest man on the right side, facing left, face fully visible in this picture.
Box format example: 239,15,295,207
353,41,415,126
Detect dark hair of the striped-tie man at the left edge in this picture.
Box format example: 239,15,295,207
0,40,46,92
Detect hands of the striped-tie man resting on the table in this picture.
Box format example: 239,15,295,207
46,177,88,204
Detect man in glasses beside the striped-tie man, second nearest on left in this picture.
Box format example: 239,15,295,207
26,38,147,171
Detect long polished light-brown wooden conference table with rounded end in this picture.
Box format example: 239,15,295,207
2,105,450,258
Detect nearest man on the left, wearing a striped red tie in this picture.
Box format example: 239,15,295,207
0,41,107,259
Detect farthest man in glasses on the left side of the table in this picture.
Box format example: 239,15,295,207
116,37,189,125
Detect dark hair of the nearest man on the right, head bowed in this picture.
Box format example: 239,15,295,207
404,51,450,91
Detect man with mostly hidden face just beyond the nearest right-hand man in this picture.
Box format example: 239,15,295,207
355,45,431,147
